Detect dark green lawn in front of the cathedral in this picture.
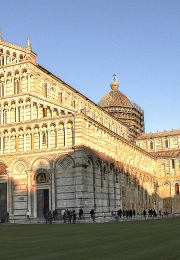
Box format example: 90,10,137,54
0,217,180,260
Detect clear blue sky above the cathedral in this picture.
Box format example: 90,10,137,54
0,0,180,133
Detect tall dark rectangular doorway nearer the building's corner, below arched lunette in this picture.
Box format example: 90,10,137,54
37,189,49,218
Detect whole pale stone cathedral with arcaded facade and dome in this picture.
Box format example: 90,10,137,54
0,35,180,218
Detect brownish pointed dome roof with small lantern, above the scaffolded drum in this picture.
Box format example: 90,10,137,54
98,81,133,108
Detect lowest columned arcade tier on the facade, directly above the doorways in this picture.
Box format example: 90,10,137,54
0,120,74,154
